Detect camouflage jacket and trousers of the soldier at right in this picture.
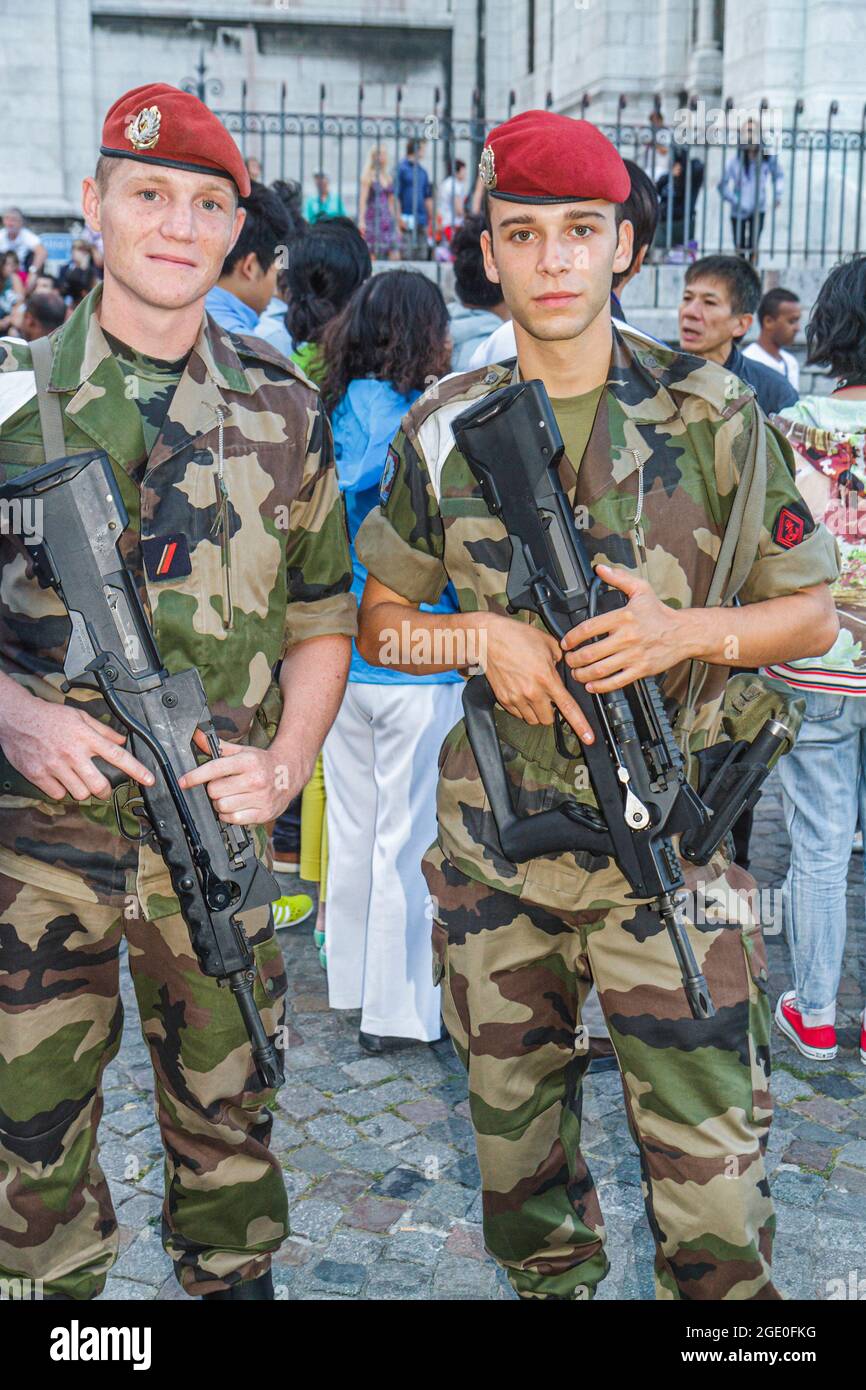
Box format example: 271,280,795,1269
357,331,835,1298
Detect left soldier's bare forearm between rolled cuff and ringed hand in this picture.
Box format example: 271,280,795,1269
271,634,352,780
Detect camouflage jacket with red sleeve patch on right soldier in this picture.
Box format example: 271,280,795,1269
356,329,837,908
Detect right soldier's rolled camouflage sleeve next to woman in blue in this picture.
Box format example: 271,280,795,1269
354,430,448,603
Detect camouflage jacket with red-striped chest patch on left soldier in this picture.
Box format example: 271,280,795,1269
0,289,356,916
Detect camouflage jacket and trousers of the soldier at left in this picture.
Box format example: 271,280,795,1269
0,291,356,1298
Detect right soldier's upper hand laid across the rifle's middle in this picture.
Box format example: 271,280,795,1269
562,564,689,694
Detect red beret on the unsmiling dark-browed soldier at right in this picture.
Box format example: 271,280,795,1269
478,111,631,203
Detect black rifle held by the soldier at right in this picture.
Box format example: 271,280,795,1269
452,381,794,1019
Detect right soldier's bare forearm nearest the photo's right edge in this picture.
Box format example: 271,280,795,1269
680,584,838,666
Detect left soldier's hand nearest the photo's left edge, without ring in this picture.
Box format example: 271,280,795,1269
0,692,153,801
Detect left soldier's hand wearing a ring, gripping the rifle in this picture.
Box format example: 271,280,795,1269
181,730,300,826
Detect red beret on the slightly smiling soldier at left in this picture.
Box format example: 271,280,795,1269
99,82,250,197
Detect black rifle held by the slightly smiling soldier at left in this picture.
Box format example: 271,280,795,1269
0,453,282,1087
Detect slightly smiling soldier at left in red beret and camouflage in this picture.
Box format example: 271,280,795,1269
0,85,356,1300
